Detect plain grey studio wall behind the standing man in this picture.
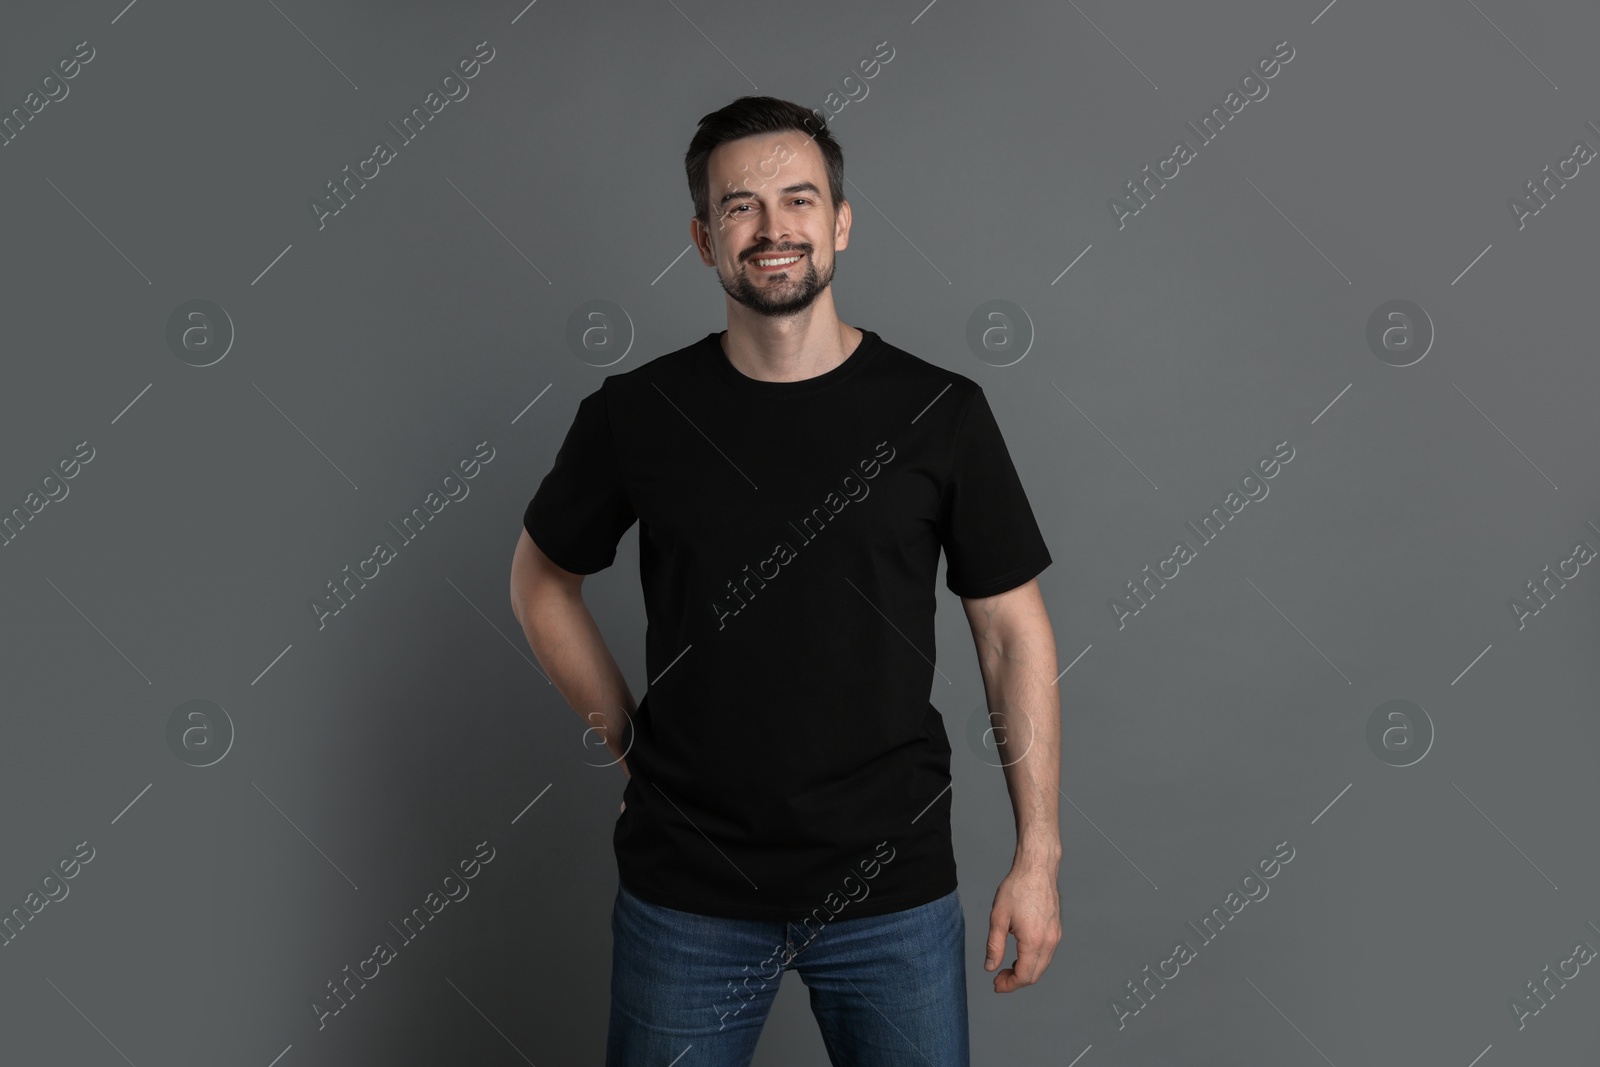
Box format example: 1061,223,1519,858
0,0,1600,1067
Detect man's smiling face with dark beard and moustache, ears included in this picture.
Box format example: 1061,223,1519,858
694,130,850,317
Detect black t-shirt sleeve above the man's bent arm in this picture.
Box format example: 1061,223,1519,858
522,386,637,574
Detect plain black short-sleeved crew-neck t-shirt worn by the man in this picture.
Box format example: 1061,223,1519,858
523,330,1051,921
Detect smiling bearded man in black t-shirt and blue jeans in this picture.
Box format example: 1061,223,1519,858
510,96,1061,1067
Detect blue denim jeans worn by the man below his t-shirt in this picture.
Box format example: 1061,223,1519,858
605,886,970,1067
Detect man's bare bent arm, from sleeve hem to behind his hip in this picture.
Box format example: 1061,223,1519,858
510,530,638,777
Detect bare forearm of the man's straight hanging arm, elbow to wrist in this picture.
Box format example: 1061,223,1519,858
982,633,1061,867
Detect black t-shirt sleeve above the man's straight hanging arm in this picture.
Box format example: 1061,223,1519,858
939,387,1051,597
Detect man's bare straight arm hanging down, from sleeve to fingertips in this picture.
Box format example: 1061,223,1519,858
962,579,1061,993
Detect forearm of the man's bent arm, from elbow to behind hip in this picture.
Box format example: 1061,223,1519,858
515,592,638,777
